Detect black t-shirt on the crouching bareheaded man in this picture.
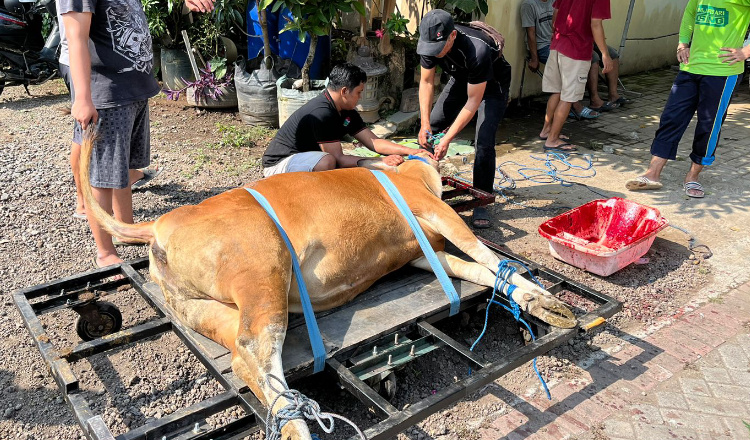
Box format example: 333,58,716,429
263,91,367,168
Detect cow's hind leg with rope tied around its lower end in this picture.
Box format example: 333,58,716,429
232,276,310,440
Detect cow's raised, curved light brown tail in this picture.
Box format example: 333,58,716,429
79,124,154,243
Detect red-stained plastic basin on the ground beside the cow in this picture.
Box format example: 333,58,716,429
539,197,668,276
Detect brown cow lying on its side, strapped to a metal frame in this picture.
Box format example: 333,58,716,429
81,129,575,439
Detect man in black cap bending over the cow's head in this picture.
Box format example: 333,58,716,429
417,9,510,228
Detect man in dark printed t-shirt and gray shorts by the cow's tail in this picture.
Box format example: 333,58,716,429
57,0,167,266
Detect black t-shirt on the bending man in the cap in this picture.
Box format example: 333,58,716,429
420,24,510,90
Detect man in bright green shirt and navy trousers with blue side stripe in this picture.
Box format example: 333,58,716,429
625,0,750,198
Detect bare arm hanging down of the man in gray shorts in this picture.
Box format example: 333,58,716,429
62,12,99,129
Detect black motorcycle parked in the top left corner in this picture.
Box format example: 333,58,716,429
0,0,60,97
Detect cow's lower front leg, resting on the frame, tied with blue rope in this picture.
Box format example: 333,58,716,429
410,252,576,328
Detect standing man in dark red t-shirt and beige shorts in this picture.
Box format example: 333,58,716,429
542,0,612,152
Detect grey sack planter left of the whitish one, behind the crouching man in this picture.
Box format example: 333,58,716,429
234,60,279,127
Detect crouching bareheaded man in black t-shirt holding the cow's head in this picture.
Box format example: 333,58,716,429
263,63,434,177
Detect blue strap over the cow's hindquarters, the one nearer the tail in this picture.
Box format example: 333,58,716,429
245,188,326,373
